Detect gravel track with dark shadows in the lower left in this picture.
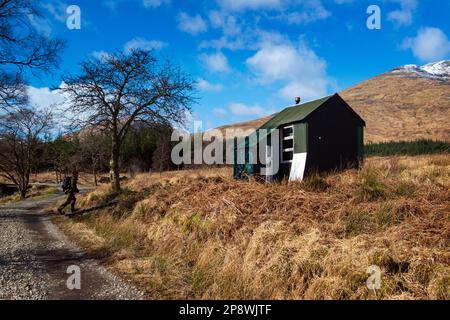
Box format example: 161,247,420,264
0,194,142,299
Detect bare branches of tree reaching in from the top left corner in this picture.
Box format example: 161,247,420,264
0,0,64,111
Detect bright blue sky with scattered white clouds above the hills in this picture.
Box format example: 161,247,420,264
29,0,450,129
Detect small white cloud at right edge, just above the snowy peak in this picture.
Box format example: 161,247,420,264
402,28,450,62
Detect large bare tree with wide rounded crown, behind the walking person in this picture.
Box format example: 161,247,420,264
61,50,194,191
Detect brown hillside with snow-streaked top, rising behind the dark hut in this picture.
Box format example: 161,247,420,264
219,61,450,142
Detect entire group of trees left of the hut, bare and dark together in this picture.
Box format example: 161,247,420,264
0,0,195,197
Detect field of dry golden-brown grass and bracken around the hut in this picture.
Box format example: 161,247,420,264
55,155,450,299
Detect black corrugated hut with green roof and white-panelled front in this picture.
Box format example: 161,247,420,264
234,94,366,181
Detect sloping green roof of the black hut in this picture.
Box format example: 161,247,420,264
259,96,332,129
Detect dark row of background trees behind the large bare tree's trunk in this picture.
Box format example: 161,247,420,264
42,126,174,185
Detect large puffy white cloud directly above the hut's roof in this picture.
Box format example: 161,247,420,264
246,41,331,101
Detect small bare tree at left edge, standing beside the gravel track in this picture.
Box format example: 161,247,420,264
0,107,52,198
